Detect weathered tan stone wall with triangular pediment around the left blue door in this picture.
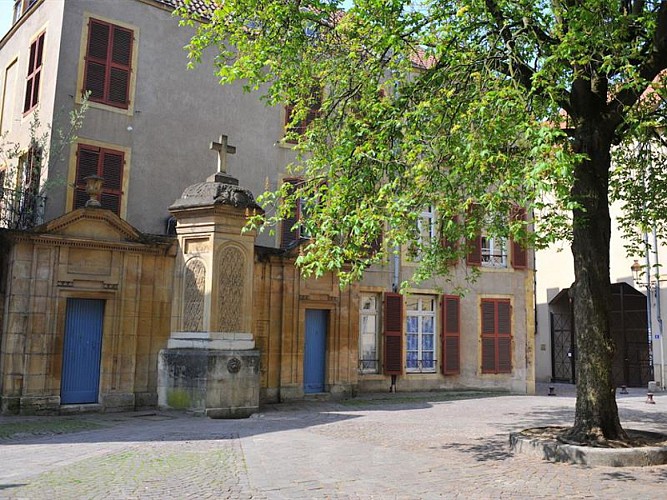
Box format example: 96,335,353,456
0,209,174,413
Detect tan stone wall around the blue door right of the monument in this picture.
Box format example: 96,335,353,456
253,255,359,402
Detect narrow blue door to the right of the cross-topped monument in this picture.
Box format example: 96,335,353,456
303,309,329,394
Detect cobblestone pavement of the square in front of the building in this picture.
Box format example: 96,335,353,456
0,389,667,499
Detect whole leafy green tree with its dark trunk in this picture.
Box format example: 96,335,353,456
181,0,667,440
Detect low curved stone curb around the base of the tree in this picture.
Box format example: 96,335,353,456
510,432,667,467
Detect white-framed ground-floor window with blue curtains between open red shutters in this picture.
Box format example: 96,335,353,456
405,295,436,373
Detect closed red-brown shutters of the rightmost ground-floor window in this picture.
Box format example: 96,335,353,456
481,299,512,373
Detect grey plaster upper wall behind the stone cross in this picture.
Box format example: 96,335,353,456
47,0,293,239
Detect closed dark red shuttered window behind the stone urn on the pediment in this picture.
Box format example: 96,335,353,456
74,144,125,215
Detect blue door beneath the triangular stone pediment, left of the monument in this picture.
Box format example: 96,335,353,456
60,299,104,404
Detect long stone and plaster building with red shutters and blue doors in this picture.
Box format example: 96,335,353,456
0,0,535,411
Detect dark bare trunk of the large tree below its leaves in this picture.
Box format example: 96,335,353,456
565,120,627,443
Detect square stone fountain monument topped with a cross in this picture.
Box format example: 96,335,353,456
158,135,261,418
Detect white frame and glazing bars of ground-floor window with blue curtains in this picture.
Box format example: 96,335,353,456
405,295,438,373
